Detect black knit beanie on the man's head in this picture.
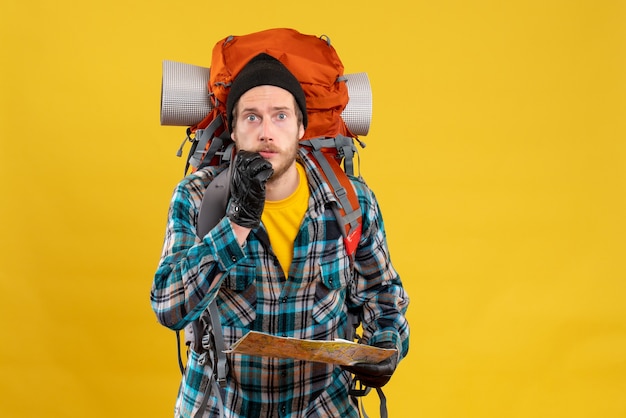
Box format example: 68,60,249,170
226,53,308,132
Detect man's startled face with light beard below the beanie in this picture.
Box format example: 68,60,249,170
231,86,304,180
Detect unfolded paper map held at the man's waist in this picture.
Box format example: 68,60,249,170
226,331,397,366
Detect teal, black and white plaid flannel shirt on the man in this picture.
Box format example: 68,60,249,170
151,150,409,417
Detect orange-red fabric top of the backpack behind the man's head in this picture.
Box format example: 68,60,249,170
195,28,354,139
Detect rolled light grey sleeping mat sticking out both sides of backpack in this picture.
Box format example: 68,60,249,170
161,60,372,135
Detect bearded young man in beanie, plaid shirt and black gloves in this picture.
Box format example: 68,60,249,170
151,54,409,418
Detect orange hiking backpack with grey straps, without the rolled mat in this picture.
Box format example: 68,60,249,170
162,28,364,255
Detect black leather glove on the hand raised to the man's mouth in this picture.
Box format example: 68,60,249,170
226,150,274,229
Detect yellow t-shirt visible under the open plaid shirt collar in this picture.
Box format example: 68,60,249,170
261,163,309,277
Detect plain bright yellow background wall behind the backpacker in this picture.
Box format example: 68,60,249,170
0,0,626,418
